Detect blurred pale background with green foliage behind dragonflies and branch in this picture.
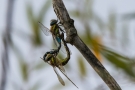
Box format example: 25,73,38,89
0,0,135,90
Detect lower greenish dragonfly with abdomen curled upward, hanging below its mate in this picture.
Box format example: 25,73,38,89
41,38,78,88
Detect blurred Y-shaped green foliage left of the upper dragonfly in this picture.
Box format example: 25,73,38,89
26,0,51,46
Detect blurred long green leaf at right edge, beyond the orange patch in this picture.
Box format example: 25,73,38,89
102,47,135,78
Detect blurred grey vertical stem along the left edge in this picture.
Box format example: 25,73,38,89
0,0,14,90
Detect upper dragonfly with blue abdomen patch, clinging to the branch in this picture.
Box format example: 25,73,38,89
39,19,65,52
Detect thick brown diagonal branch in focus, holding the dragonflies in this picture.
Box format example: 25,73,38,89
53,0,122,90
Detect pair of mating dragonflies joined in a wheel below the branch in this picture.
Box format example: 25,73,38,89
39,19,78,88
